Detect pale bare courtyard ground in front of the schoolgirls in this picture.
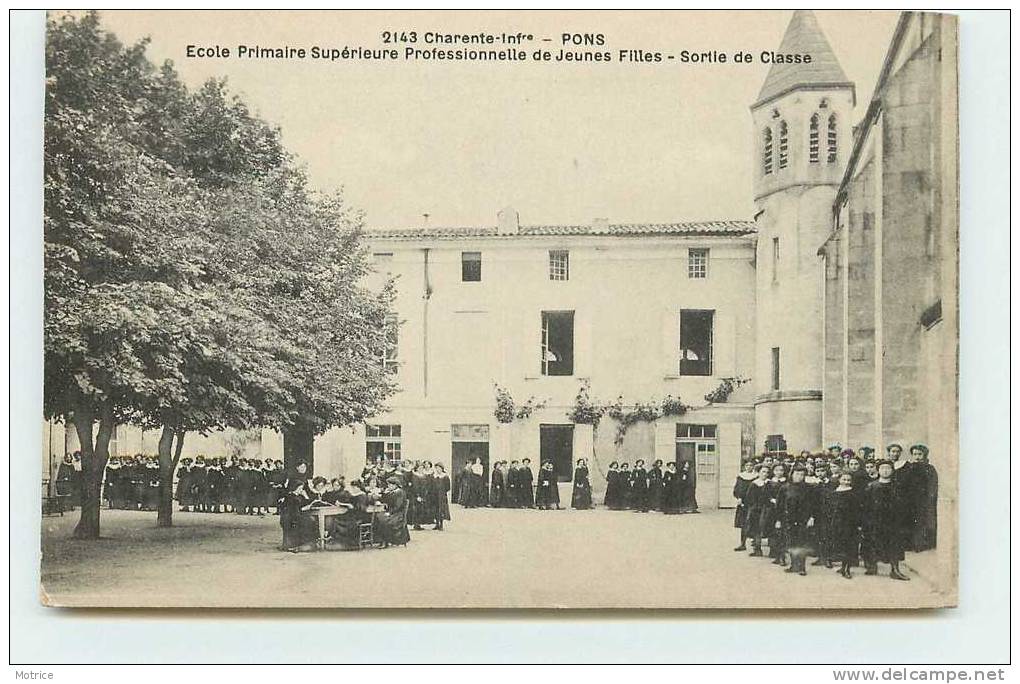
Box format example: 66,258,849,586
41,506,948,609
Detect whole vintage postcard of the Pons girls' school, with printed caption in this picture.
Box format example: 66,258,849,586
40,10,960,610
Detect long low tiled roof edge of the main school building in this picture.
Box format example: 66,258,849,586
365,221,755,240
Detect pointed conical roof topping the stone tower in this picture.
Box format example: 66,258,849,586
752,9,854,108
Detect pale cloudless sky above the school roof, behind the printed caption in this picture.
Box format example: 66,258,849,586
91,11,898,227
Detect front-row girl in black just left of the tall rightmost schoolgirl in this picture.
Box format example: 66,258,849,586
861,460,910,581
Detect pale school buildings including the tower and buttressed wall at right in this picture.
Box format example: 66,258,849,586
44,11,958,508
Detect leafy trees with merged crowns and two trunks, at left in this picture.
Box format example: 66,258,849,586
44,13,395,537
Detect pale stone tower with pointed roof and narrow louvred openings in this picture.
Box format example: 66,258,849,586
751,10,855,452
